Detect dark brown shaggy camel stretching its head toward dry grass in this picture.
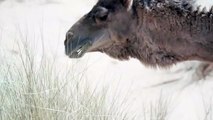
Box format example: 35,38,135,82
64,0,213,67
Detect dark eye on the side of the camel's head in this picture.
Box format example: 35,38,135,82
95,7,109,22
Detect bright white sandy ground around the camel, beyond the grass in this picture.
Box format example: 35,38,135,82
0,0,213,120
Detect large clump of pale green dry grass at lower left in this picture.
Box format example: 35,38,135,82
0,39,134,120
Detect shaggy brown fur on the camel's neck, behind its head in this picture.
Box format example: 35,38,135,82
99,1,213,66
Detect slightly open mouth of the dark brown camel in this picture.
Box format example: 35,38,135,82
66,40,92,58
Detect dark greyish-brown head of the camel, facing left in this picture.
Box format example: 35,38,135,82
64,0,134,58
